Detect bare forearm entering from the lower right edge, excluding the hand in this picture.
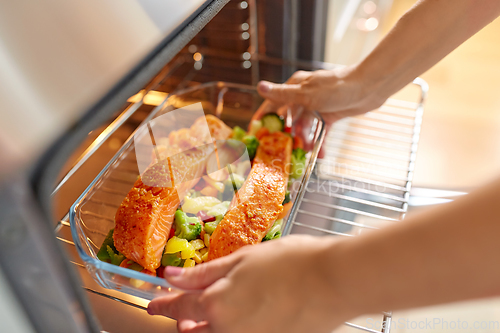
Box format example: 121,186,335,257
329,176,500,314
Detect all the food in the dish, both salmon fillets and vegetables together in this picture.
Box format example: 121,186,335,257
98,114,305,276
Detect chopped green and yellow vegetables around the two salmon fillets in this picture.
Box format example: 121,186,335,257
97,113,306,276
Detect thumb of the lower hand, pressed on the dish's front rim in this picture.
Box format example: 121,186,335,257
164,255,241,290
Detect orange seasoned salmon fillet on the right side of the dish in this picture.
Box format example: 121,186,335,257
208,132,292,260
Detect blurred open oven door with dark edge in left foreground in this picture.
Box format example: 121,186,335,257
0,0,228,333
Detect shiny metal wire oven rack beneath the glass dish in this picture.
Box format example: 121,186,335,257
53,57,428,333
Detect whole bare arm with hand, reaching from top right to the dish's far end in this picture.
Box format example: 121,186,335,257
258,0,500,120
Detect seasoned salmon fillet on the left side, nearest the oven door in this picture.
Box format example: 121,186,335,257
113,115,232,271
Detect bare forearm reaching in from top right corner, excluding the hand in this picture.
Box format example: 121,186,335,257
355,0,500,99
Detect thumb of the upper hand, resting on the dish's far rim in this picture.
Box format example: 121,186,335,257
257,81,307,104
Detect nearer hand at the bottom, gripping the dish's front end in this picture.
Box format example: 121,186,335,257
148,236,358,333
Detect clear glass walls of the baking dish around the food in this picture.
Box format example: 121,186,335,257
70,82,325,299
